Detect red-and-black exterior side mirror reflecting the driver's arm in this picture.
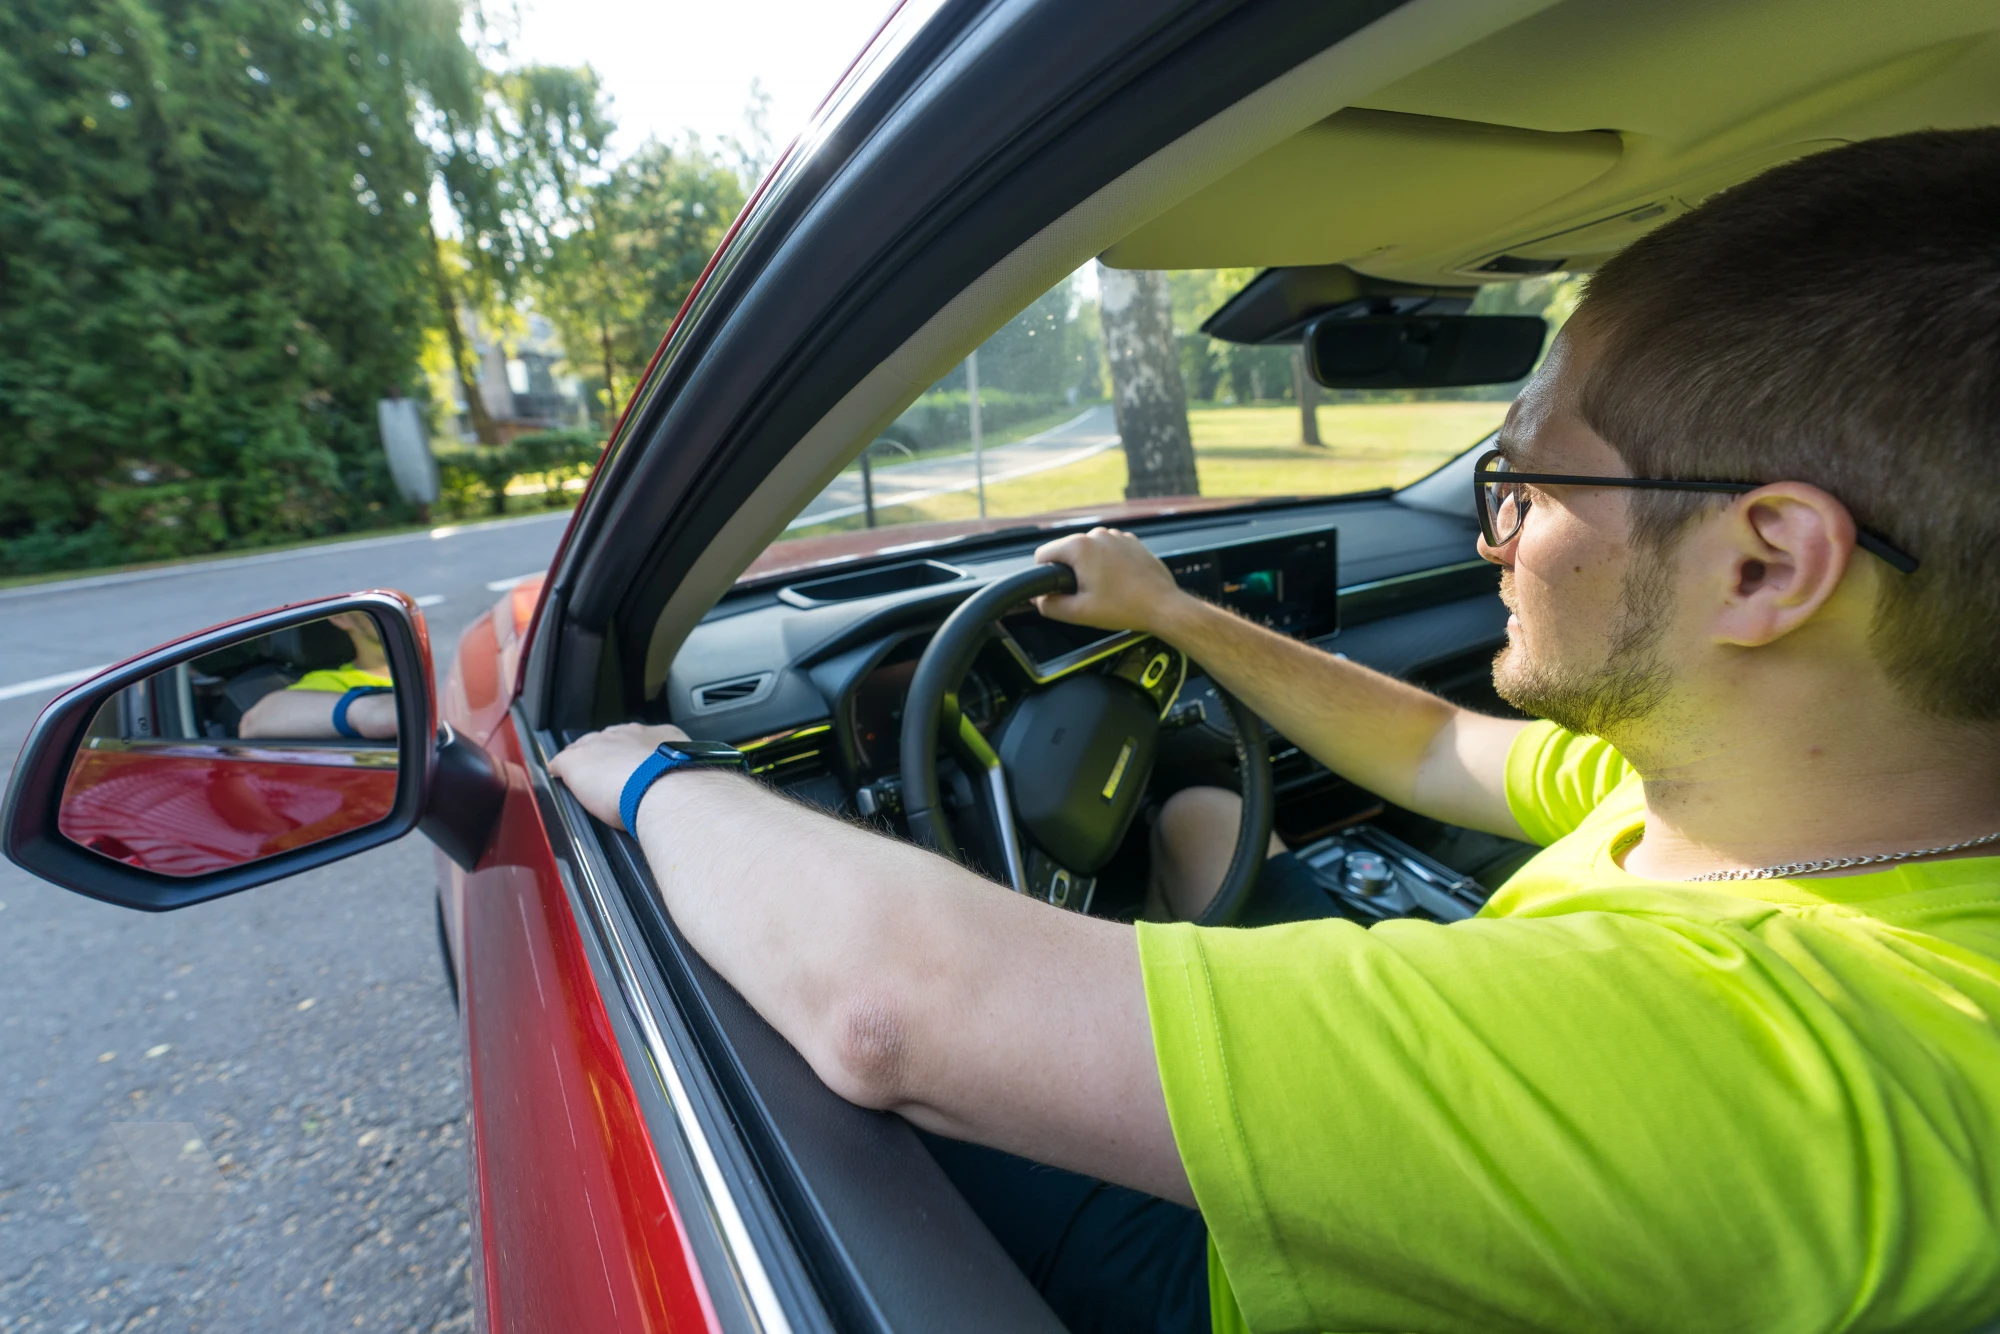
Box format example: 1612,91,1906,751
0,592,504,912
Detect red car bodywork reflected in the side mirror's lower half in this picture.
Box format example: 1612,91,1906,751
58,744,396,876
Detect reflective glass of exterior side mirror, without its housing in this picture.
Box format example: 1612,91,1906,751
56,610,398,876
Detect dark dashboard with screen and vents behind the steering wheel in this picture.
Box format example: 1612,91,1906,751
654,488,1506,896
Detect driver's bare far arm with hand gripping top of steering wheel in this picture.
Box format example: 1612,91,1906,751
1036,528,1526,838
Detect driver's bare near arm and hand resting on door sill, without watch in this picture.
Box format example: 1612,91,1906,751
550,724,1194,1204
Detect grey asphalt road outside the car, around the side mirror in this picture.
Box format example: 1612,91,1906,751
0,514,566,1334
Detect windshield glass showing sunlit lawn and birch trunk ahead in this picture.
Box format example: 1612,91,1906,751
746,264,1580,578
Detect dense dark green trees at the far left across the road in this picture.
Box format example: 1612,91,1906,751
0,0,476,572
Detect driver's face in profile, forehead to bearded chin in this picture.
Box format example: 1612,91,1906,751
1480,332,1676,736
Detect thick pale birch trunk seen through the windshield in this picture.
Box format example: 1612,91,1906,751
1098,264,1202,500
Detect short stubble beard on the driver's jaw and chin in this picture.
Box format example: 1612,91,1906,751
1494,552,1672,742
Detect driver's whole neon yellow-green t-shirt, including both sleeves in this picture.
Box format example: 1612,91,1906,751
1138,724,2000,1334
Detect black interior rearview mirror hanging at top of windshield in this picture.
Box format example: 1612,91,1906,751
1306,314,1548,390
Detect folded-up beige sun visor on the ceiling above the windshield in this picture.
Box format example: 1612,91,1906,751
1104,108,1622,268
